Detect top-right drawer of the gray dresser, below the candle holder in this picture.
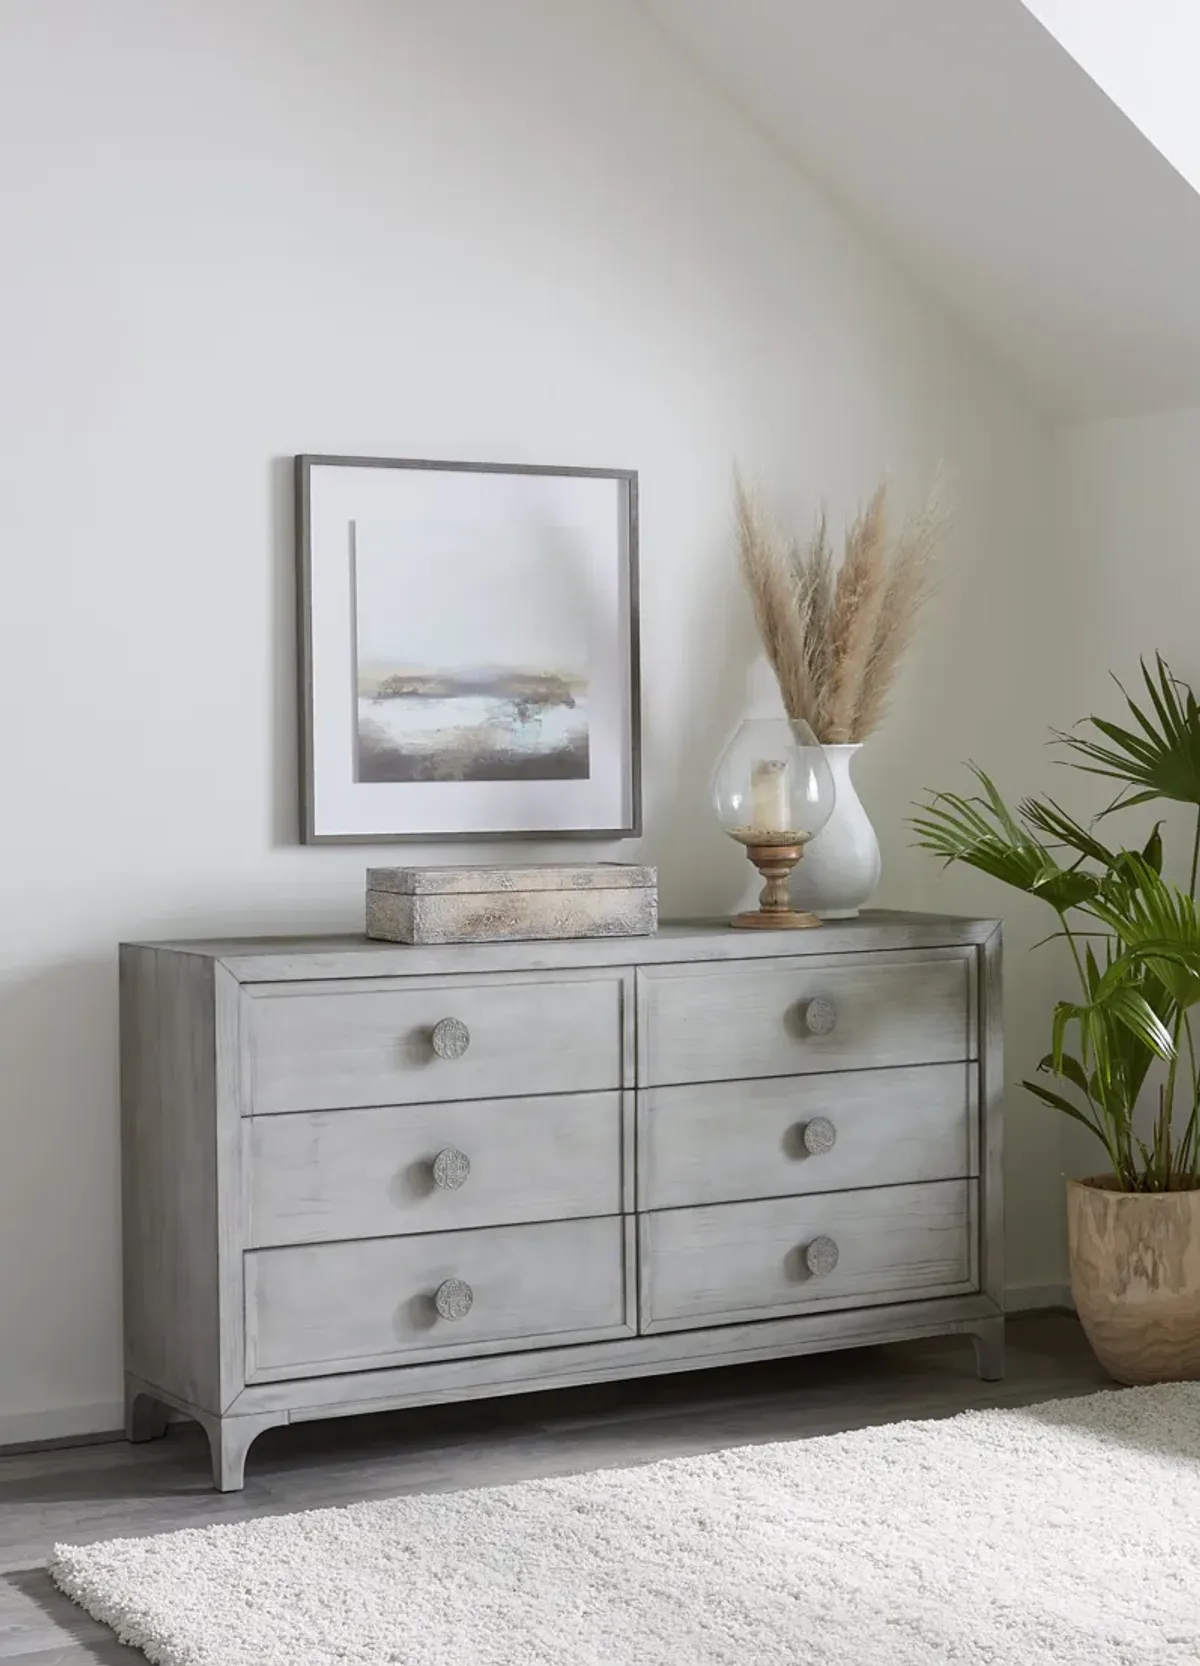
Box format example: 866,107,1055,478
637,950,977,1086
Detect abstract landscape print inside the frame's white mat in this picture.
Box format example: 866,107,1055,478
353,520,590,783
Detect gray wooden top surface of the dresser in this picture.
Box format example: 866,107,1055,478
125,910,1000,983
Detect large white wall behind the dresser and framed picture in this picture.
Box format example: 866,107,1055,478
0,0,1060,1438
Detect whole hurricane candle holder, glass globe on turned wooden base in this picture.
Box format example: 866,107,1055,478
712,718,833,931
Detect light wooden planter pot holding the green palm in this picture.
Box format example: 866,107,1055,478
1067,1175,1200,1383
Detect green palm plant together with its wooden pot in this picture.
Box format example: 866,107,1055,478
912,656,1200,1383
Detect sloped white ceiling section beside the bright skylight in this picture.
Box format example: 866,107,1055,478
643,0,1200,417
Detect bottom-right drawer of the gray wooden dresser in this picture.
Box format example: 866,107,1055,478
640,1180,977,1331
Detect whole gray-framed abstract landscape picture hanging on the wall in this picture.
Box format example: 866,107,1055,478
295,456,642,843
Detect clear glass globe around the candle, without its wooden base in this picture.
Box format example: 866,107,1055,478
712,718,835,846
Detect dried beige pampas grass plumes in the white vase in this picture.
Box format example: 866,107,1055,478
733,476,948,745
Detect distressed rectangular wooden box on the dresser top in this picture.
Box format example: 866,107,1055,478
367,861,658,943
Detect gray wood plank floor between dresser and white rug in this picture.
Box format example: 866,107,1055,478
0,1313,1112,1666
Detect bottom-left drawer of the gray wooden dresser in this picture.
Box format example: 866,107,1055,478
245,1216,633,1383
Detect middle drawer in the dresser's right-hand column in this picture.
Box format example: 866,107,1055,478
638,1063,978,1210
